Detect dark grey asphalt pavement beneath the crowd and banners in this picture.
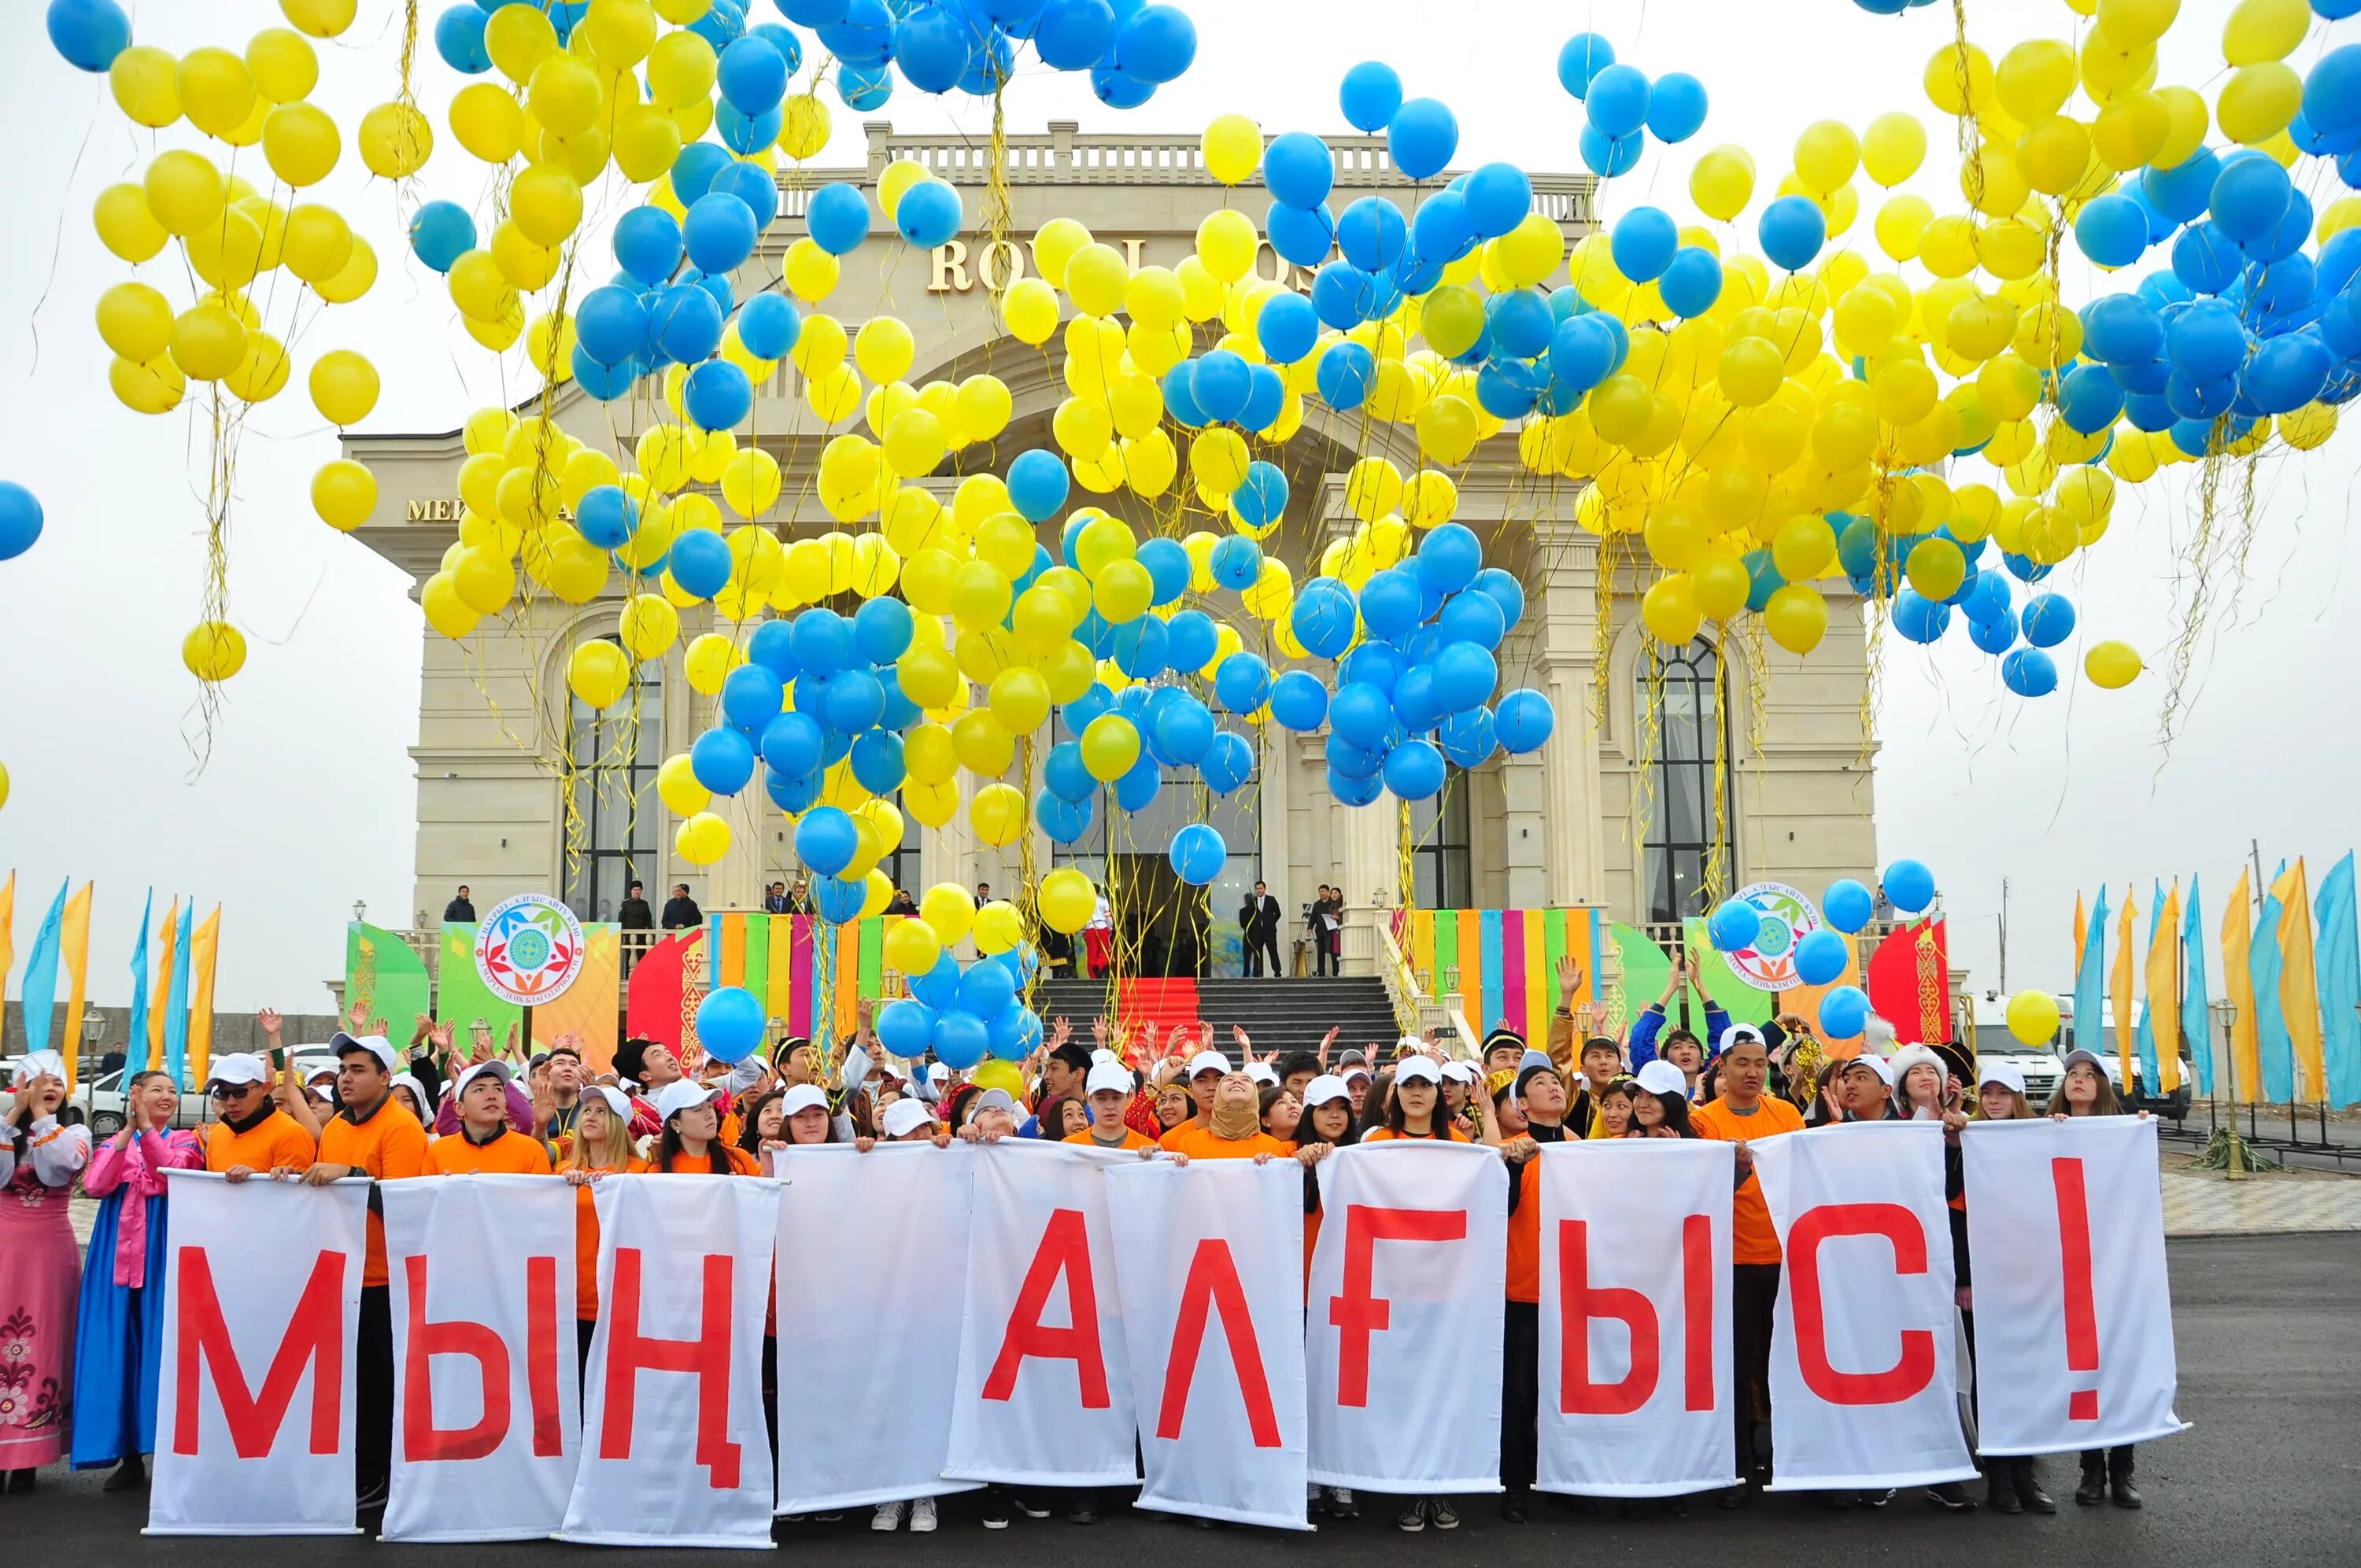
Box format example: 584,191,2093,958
18,1235,2361,1568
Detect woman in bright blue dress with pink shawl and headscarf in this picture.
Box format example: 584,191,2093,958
73,1072,205,1492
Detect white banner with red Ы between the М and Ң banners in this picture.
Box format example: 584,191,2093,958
382,1176,581,1542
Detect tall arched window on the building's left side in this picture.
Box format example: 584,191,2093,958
564,637,663,921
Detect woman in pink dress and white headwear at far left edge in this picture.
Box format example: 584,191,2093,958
0,1051,90,1492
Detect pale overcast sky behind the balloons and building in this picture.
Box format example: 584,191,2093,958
0,0,2361,1011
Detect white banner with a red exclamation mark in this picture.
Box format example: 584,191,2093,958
1962,1117,2182,1455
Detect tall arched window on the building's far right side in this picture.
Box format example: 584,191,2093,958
1634,637,1735,921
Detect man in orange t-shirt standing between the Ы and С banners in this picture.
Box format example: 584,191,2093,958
1688,1032,1804,1509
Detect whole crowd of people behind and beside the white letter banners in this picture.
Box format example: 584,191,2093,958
0,964,2139,1530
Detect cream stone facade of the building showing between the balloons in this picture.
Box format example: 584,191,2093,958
347,127,1875,944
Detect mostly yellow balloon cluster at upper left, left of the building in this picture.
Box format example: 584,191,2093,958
47,0,392,682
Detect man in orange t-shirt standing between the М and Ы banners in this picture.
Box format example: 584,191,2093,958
302,1030,427,1514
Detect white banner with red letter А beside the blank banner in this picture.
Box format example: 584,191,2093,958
944,1138,1140,1485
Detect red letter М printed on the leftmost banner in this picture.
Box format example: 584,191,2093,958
172,1247,349,1459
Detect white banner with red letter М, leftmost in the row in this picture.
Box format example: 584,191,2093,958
146,1171,368,1535
